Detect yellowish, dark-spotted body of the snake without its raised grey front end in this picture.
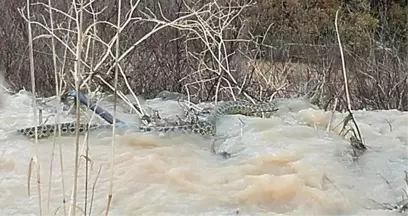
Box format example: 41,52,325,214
18,101,277,139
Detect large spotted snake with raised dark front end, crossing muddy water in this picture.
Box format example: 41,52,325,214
17,91,277,139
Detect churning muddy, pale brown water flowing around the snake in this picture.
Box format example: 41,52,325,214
0,92,408,216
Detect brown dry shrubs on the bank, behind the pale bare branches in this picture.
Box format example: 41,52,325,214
0,0,408,110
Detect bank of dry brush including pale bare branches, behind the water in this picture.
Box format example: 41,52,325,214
0,0,408,110
